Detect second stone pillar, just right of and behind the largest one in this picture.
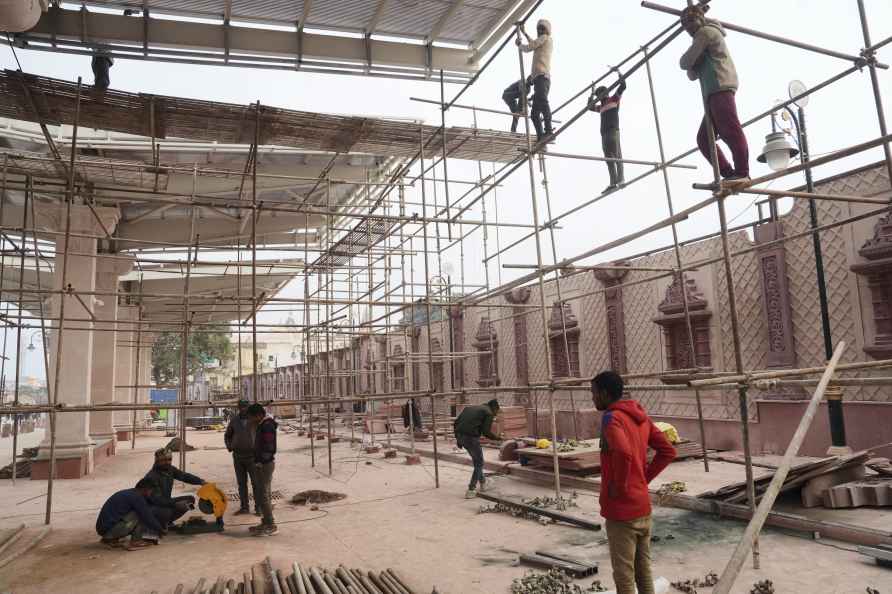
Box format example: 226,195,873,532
90,256,133,456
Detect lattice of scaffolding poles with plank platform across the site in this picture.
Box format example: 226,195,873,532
0,0,892,584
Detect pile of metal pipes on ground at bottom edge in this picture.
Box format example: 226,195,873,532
159,557,424,594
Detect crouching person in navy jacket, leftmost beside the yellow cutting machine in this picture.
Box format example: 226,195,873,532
96,478,164,550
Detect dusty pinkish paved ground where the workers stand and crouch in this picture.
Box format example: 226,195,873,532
0,432,892,594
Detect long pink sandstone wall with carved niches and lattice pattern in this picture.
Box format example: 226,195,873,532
240,165,892,455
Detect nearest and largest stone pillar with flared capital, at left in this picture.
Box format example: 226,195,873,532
31,205,118,479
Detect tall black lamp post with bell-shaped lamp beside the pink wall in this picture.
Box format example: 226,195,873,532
758,81,849,454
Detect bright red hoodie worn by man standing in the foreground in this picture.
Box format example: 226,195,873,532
600,400,675,522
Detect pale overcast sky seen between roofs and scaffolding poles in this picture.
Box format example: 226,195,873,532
0,0,892,375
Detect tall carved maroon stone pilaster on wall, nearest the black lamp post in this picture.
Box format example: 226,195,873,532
754,222,796,367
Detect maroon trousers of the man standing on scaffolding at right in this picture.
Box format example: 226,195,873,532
697,91,750,177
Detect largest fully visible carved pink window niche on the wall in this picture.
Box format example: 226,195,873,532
654,275,712,370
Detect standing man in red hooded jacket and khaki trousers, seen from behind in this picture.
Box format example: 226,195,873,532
592,371,675,594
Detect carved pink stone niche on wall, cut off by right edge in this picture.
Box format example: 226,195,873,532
851,214,892,359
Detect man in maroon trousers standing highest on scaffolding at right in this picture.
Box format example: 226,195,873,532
679,6,750,184
